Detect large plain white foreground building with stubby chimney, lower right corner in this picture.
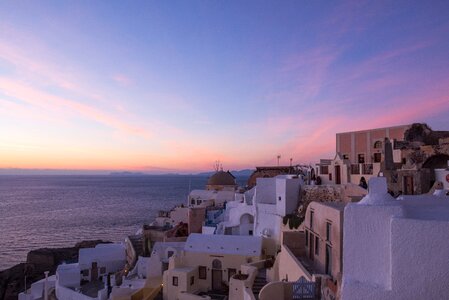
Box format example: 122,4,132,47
341,177,449,299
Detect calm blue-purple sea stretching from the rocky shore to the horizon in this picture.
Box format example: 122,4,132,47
0,175,246,270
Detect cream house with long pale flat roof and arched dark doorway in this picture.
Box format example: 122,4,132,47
163,234,262,300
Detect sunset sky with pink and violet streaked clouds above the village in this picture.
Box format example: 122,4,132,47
0,0,449,173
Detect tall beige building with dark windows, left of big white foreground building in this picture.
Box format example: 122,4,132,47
266,202,345,300
